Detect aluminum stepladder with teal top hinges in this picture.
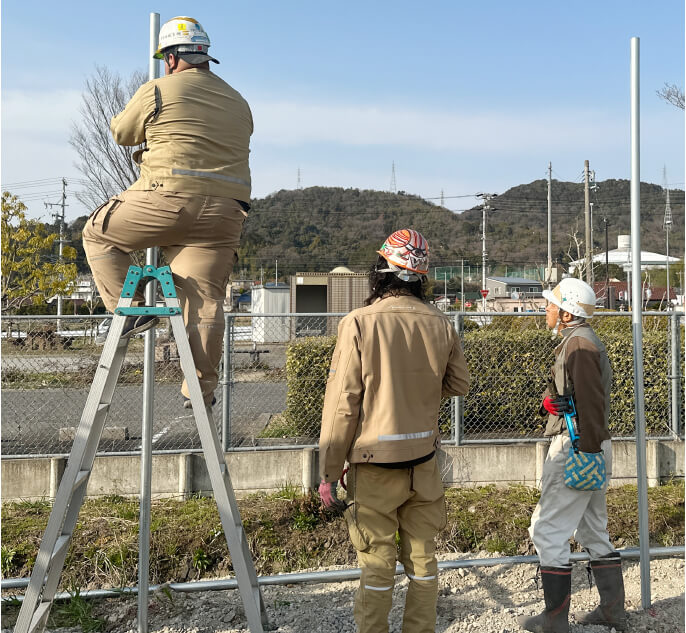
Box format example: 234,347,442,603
14,266,270,633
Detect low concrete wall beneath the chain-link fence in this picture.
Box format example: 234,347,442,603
2,440,684,501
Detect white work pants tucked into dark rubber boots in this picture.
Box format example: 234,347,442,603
529,434,615,567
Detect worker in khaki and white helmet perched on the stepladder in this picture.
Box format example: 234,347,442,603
83,17,253,407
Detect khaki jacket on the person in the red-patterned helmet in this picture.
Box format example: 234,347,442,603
319,295,469,481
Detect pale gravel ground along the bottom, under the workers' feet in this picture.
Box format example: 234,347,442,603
3,552,684,633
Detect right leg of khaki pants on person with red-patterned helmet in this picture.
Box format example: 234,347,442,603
398,458,446,633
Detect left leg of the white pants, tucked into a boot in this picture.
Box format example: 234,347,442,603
529,435,593,567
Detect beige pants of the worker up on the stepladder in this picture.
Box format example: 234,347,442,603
83,190,246,404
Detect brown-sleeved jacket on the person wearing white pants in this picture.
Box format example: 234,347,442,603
543,323,612,453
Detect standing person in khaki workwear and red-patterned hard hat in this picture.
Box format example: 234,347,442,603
319,230,469,633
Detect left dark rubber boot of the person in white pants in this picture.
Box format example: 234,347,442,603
517,565,572,633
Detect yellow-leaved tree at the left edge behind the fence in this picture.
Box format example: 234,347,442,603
1,191,77,310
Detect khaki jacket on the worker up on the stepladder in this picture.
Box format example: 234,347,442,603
110,68,253,202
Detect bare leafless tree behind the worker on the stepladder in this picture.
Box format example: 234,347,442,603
69,66,147,209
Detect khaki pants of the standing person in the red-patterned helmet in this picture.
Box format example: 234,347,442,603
345,457,446,633
